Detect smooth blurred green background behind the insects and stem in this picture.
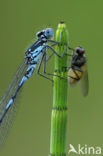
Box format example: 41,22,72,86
0,0,103,156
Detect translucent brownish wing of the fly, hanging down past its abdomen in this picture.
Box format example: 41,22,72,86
79,64,89,96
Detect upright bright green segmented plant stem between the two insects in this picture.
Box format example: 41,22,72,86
50,23,68,156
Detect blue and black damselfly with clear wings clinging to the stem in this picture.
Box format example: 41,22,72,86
0,28,68,145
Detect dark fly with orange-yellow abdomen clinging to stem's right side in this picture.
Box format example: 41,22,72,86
68,46,89,96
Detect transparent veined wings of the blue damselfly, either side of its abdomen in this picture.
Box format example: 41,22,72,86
0,60,27,148
